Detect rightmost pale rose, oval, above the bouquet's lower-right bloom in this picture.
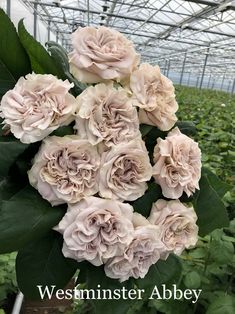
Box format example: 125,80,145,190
153,128,201,199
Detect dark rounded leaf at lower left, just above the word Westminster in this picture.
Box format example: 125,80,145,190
16,231,77,299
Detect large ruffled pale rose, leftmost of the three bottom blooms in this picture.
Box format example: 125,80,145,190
54,197,134,266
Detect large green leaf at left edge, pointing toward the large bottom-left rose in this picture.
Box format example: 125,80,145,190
0,187,64,254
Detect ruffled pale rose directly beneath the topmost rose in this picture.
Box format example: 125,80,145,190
75,84,140,146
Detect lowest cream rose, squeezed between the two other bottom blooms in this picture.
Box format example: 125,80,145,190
104,225,166,282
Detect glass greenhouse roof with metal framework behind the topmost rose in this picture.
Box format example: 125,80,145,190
21,0,235,92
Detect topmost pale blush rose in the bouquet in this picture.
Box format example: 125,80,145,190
69,26,140,83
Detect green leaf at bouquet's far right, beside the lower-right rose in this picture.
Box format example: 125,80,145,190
194,174,229,236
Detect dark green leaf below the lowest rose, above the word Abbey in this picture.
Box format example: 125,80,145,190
136,254,182,293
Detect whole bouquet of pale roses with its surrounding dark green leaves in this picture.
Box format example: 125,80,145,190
0,7,228,312
